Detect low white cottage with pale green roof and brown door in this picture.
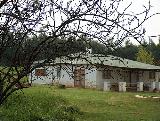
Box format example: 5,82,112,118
29,54,160,89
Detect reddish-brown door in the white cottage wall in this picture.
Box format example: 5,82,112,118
74,68,85,87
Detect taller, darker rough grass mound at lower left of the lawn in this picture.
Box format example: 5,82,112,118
0,87,80,121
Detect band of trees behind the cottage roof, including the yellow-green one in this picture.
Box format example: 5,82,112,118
21,34,160,65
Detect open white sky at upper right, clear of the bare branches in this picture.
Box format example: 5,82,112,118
125,0,160,43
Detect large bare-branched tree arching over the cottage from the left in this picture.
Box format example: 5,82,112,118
0,0,158,104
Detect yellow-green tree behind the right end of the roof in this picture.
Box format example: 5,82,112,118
136,46,154,64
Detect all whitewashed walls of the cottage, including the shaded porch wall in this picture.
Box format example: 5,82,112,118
29,65,160,89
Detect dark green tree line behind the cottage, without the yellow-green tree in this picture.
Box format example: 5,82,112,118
1,33,160,65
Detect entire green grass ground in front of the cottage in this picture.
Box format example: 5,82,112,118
0,86,160,121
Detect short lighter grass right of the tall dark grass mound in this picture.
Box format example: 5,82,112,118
53,89,160,121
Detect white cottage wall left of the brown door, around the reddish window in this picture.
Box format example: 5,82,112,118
29,65,74,86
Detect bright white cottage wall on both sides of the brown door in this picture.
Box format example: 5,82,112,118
29,65,96,88
